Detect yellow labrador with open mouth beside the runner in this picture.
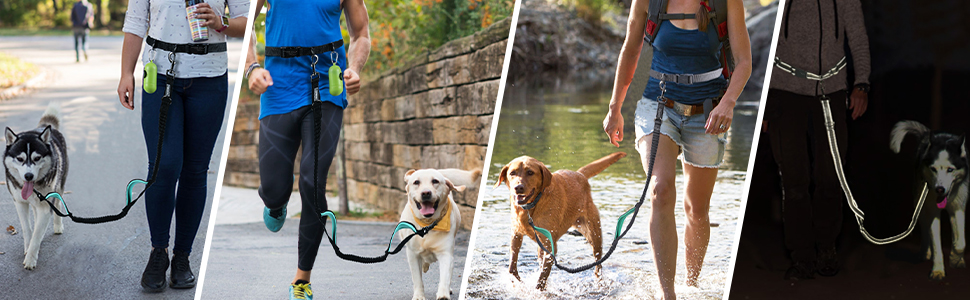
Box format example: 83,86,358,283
400,169,481,300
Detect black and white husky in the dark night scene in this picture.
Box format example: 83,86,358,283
889,121,968,280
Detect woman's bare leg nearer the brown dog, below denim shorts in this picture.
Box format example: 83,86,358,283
639,134,679,300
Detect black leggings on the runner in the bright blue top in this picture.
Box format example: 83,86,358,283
259,102,344,271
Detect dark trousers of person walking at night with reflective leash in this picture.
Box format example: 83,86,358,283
765,89,848,262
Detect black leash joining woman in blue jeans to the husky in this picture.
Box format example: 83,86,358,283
34,49,175,224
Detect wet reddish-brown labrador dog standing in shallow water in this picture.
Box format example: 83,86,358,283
495,152,626,290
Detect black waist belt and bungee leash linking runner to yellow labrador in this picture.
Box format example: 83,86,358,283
266,40,441,264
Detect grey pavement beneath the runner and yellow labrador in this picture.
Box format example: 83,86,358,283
202,199,469,299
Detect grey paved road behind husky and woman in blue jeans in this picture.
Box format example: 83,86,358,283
0,36,241,299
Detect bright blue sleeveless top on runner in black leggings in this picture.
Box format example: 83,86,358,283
259,0,347,119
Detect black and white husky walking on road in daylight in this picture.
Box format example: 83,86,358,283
3,104,67,270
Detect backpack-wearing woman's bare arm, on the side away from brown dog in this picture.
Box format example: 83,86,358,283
704,0,751,134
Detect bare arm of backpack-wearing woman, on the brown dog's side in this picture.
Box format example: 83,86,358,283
603,0,650,147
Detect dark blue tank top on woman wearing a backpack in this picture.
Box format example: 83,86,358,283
643,20,727,104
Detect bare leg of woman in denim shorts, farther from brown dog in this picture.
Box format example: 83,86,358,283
684,163,717,286
